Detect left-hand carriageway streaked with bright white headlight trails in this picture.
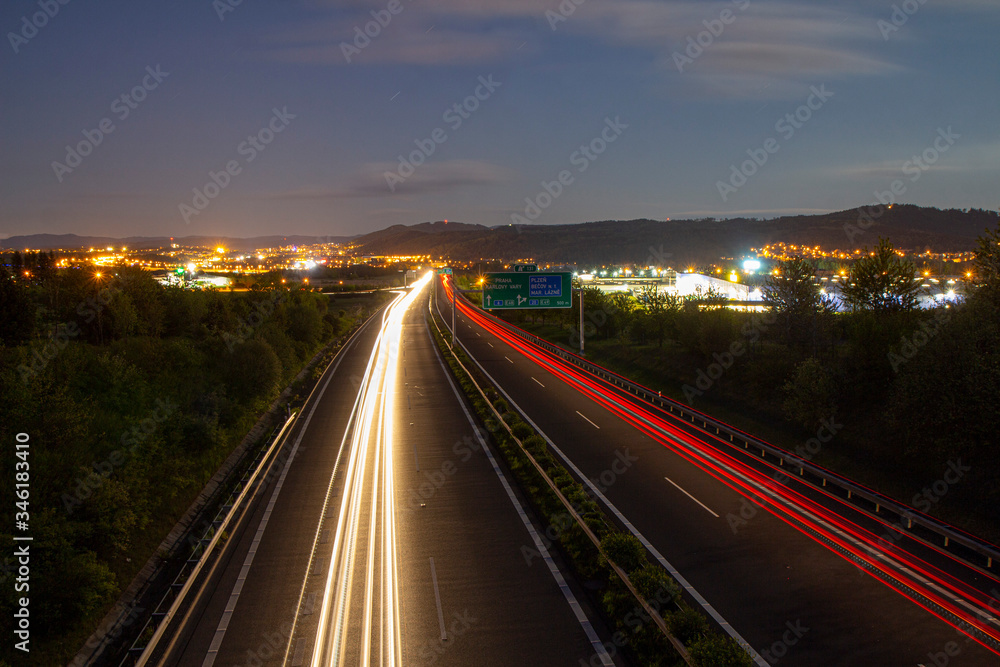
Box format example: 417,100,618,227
149,277,621,667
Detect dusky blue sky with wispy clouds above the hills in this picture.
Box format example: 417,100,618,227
0,0,1000,237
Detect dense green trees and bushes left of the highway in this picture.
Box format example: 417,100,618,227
0,264,380,664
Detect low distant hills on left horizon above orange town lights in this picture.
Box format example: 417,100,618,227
0,234,355,250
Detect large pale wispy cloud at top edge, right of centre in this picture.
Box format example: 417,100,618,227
580,0,901,99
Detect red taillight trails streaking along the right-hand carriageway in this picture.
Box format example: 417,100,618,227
445,281,1000,655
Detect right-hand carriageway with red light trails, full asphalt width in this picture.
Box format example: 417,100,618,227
437,274,1000,666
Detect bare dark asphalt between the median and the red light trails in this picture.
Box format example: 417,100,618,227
436,278,1000,667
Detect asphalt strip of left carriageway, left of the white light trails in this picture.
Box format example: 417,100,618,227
168,311,381,665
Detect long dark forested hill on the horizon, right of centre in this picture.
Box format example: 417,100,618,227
351,204,997,266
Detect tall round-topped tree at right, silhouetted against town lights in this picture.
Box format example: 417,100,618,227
840,238,921,313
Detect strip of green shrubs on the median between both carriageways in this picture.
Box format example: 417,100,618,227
433,316,753,667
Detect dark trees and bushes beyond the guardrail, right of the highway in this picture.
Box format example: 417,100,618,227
490,227,1000,541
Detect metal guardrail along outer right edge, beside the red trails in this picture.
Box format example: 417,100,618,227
464,296,1000,570
